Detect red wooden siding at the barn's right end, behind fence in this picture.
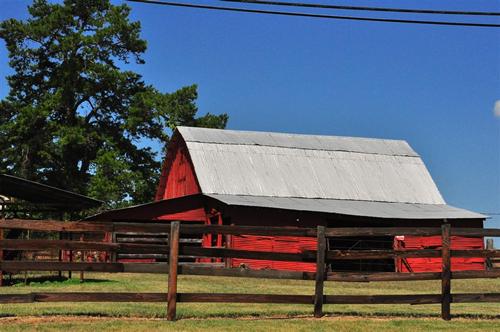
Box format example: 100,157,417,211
395,236,484,272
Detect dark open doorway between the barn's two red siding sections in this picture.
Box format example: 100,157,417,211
328,236,395,272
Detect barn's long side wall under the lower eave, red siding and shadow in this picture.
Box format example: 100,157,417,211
226,208,484,272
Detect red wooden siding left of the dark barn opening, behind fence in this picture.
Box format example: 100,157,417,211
231,235,316,272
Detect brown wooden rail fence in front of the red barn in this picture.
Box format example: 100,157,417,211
0,219,500,320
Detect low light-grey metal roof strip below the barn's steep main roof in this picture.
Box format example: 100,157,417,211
205,194,486,219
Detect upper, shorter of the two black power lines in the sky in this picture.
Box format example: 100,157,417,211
220,0,500,16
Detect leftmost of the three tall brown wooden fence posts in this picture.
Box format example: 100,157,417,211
167,221,180,321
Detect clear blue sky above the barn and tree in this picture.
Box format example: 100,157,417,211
0,0,500,235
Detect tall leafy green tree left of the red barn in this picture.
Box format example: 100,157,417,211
0,0,228,205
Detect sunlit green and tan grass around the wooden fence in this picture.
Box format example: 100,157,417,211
0,273,500,331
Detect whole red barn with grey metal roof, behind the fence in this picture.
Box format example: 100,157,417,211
91,127,486,272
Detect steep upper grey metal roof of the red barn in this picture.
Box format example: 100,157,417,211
178,127,445,204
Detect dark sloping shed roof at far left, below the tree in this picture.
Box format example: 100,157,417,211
0,174,104,211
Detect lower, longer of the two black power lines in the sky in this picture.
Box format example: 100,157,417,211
127,0,500,28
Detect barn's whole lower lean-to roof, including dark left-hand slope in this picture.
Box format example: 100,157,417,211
87,194,487,221
